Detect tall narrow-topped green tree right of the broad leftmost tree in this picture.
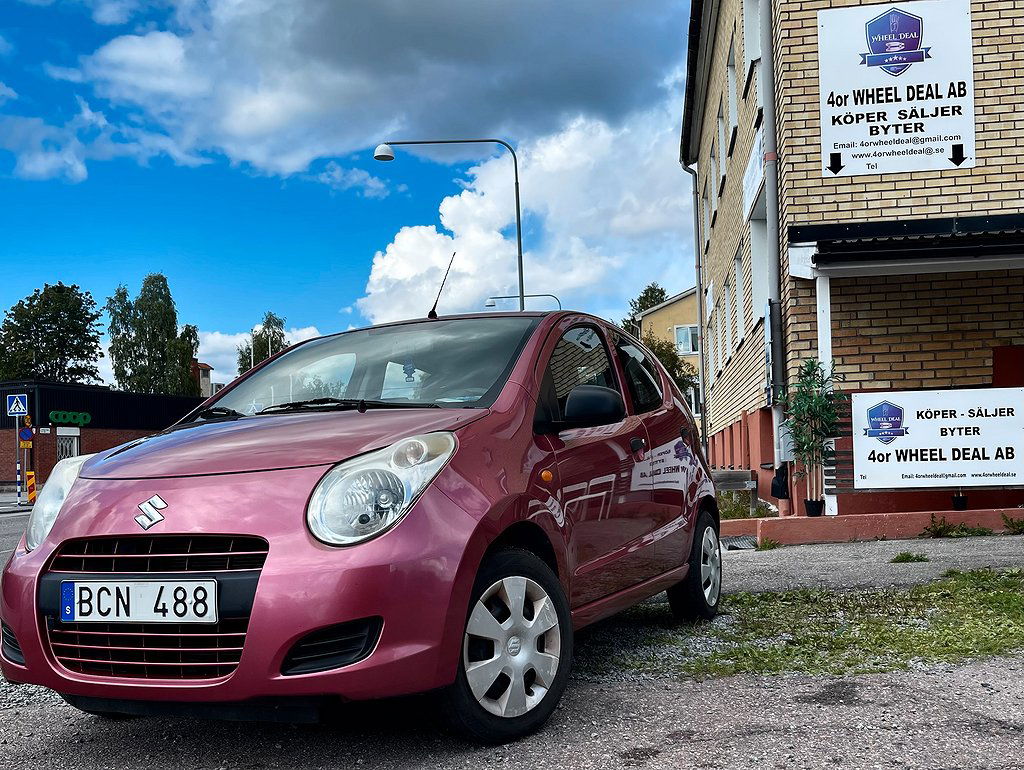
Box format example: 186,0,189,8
106,272,199,395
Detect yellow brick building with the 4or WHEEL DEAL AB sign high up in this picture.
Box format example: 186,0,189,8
680,0,1024,513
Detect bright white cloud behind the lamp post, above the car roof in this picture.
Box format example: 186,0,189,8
357,92,693,323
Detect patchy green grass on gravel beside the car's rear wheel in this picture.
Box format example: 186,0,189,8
578,569,1024,677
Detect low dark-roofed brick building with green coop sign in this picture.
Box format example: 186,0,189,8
0,380,203,483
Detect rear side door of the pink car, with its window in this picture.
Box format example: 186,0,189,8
615,335,697,574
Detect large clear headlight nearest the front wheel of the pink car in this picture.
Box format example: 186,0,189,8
306,433,456,546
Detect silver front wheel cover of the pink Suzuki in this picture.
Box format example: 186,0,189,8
462,575,561,718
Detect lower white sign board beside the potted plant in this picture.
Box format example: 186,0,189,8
852,388,1024,489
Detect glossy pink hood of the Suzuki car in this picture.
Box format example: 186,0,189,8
82,409,488,478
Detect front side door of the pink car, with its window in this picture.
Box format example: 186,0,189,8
541,325,650,607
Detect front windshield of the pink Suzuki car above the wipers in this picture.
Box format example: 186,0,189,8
200,316,540,419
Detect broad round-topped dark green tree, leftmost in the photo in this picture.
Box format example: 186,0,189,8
0,283,103,384
